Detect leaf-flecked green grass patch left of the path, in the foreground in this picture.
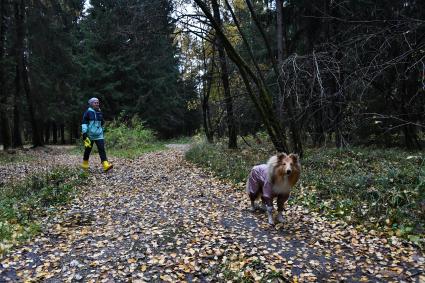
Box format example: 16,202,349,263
0,168,87,256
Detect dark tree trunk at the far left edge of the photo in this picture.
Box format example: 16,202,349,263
0,0,12,150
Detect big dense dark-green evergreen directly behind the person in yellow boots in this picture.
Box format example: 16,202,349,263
79,0,199,137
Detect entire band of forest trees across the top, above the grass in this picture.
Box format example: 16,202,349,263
0,0,425,153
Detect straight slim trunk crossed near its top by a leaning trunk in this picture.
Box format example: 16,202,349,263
211,0,238,149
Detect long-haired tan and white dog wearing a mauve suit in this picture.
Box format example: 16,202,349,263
246,153,301,225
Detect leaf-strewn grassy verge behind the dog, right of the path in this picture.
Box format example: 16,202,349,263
186,139,425,248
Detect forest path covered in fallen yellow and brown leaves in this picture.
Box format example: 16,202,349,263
0,147,425,282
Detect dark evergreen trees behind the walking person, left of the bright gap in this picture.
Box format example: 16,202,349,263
0,0,200,148
